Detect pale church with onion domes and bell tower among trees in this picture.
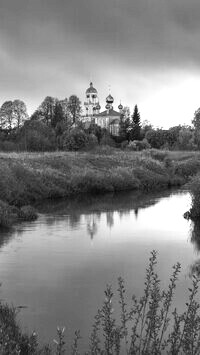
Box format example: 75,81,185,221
82,82,123,136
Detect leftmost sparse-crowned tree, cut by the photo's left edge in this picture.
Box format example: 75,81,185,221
0,101,15,130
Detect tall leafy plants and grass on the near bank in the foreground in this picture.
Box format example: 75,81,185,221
0,251,200,355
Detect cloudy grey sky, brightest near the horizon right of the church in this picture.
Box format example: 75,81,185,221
0,0,200,128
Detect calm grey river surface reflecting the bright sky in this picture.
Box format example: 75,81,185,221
0,192,199,348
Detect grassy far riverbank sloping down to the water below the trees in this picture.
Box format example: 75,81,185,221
0,149,200,227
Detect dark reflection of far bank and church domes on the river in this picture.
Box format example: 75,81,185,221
36,191,178,240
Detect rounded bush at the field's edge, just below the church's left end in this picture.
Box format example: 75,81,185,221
63,128,88,151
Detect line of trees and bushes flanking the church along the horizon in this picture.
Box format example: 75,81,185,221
0,95,200,151
